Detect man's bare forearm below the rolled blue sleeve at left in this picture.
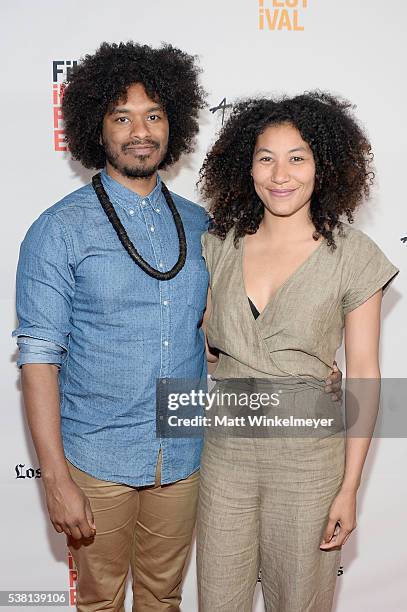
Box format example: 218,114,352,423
21,363,70,486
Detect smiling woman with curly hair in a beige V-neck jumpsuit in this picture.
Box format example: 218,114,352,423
197,92,398,612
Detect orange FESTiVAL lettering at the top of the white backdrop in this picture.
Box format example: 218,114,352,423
259,0,308,32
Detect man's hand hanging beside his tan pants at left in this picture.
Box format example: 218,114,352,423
45,477,96,540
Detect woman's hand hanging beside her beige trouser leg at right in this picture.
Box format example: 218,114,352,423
319,490,356,550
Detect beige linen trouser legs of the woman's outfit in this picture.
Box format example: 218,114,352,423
197,436,345,612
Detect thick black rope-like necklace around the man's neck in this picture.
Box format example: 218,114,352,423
92,172,187,280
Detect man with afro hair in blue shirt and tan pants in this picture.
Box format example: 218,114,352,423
13,42,208,612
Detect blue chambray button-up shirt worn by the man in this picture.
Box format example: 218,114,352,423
13,171,208,486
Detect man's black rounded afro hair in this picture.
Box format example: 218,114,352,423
62,41,206,169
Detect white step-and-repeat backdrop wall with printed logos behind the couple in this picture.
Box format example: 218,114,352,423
0,0,407,612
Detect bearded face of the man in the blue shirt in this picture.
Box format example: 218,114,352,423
101,83,169,178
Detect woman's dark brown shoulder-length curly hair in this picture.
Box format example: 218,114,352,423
198,91,374,249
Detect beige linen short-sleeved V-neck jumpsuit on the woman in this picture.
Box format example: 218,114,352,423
197,224,398,612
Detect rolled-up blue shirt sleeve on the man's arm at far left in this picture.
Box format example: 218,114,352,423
12,213,75,366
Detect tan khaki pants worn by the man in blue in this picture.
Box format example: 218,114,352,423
68,453,199,612
